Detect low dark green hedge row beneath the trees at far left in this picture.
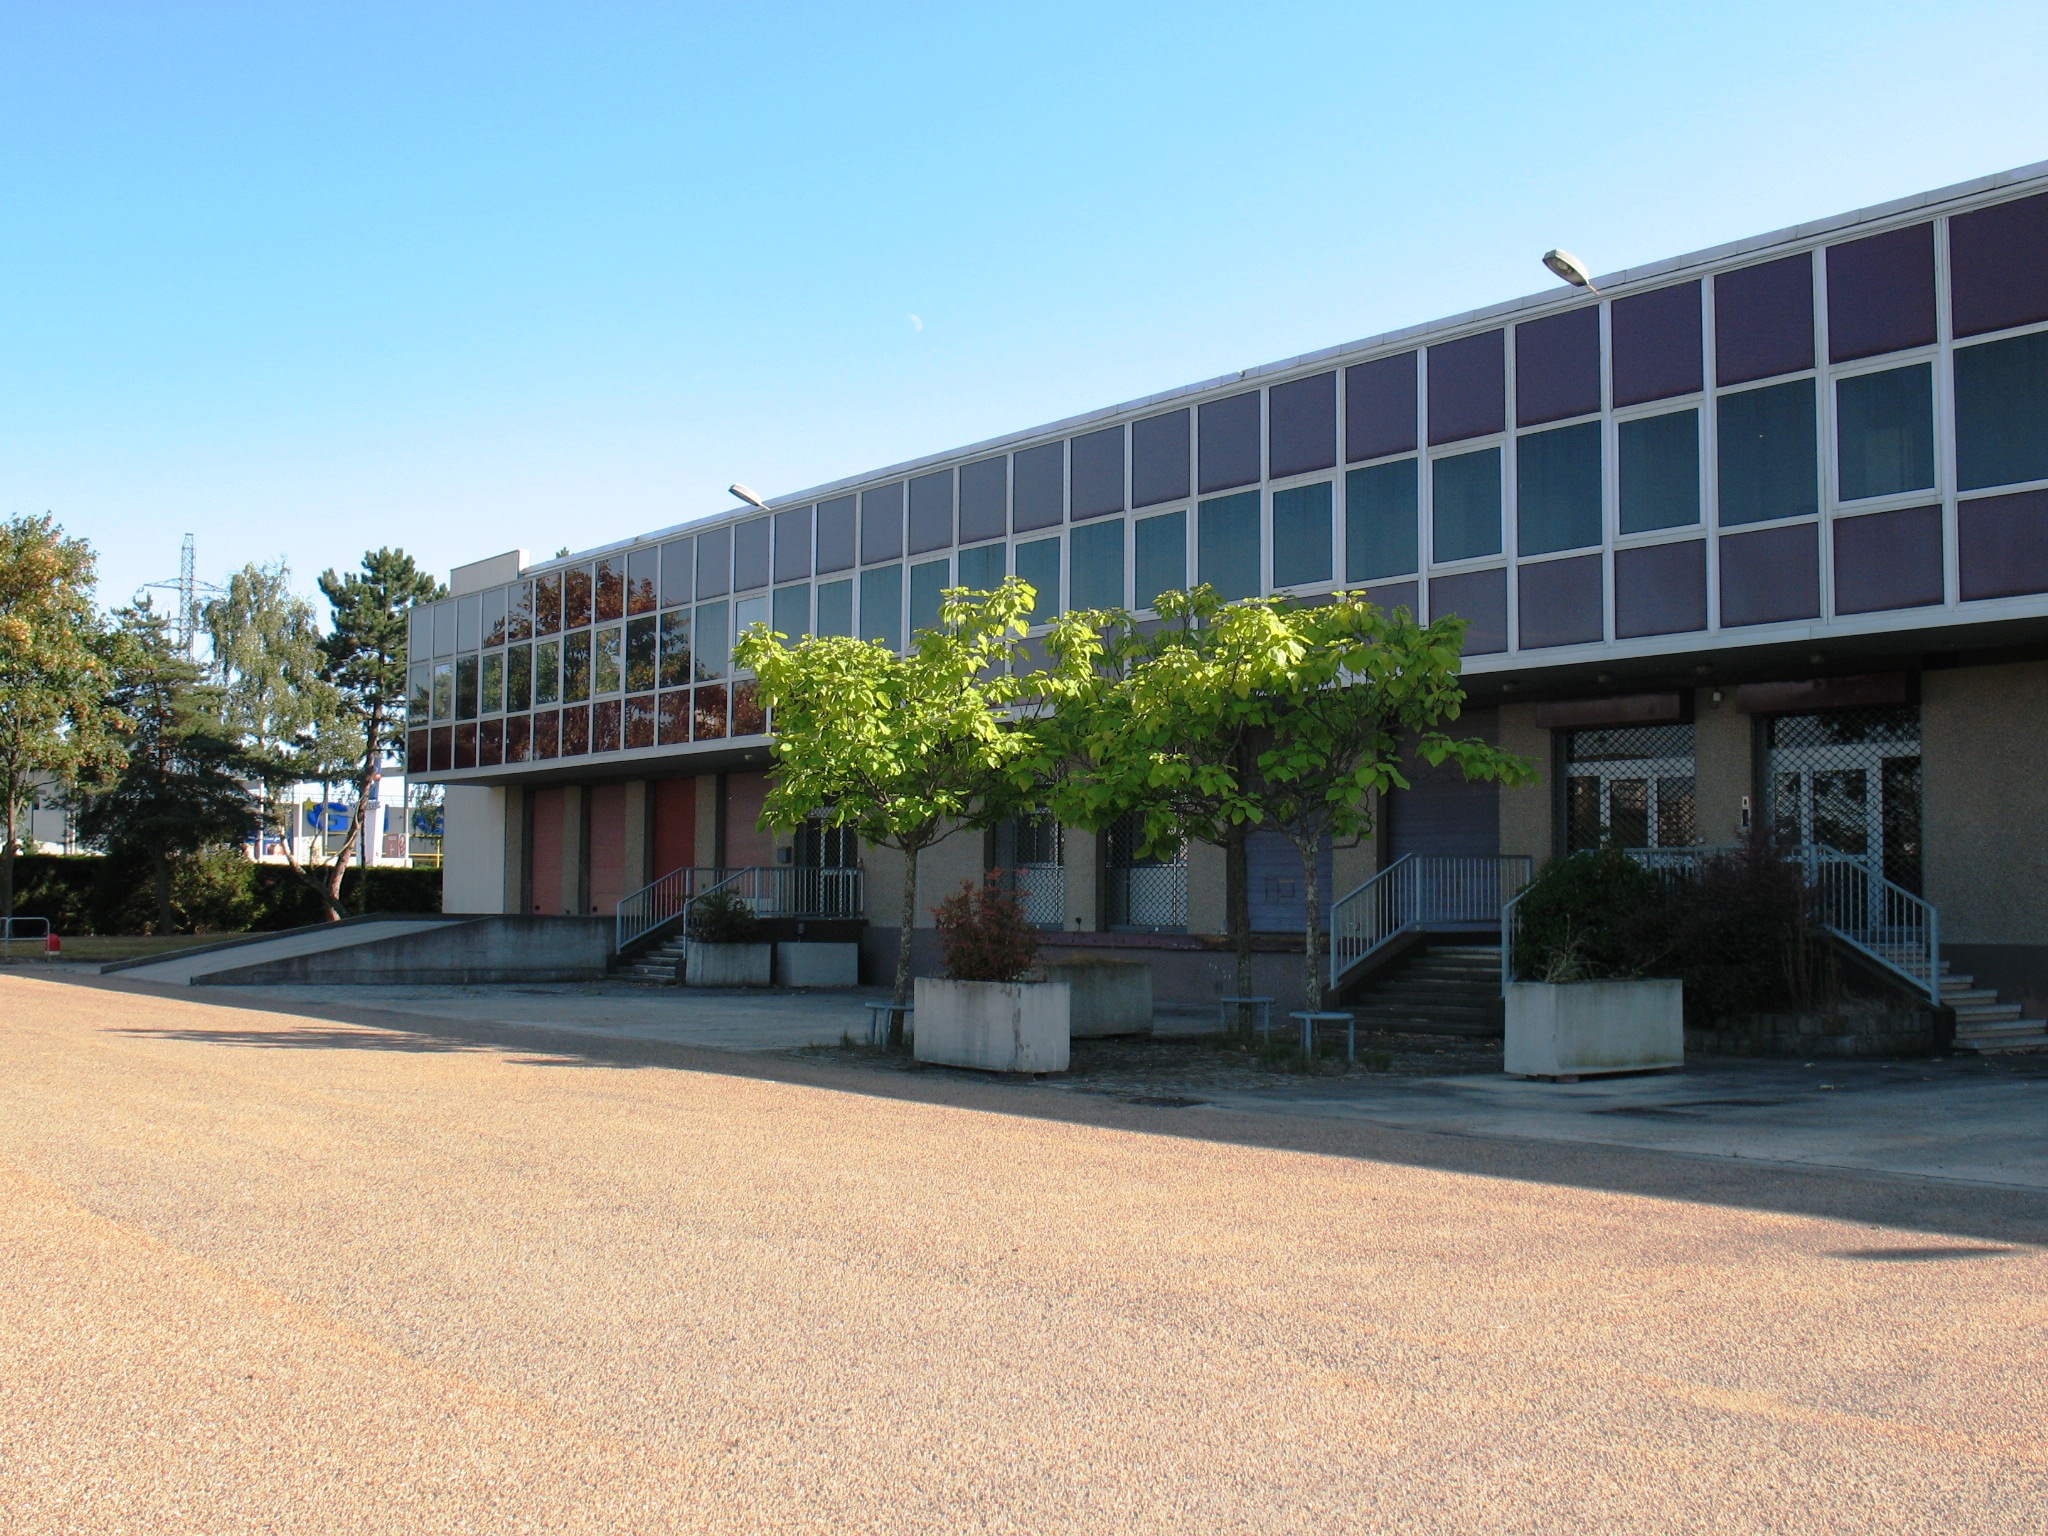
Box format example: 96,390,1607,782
14,850,440,934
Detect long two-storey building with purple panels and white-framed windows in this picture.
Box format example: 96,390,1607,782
410,164,2048,1028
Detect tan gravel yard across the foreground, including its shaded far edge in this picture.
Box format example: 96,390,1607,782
12,975,2048,1536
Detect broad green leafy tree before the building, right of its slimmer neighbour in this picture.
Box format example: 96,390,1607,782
1053,588,1532,1008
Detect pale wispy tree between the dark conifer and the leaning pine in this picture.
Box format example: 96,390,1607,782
203,561,362,893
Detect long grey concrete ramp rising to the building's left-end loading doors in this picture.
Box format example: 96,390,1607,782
100,915,612,987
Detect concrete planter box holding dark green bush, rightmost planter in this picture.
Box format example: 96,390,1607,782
1505,977,1686,1077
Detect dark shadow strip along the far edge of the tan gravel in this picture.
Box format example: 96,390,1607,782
51,977,2048,1264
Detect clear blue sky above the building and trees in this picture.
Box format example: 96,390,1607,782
0,0,2048,614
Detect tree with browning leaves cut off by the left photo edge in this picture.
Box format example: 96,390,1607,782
0,516,119,933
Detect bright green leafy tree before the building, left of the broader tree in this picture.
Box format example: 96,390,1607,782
733,578,1036,1044
